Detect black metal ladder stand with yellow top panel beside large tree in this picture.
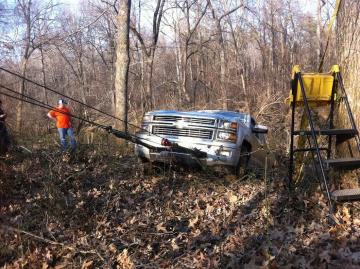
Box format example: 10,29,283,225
288,65,360,214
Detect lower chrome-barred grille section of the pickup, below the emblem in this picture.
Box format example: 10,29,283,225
153,126,213,139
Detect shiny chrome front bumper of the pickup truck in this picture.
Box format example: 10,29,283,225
135,136,240,167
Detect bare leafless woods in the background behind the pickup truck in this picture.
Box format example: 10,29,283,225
0,0,360,147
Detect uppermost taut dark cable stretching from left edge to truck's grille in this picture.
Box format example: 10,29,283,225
0,66,163,139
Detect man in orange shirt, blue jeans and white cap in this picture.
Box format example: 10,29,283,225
47,99,76,151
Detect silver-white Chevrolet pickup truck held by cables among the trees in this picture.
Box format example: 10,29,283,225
135,110,274,174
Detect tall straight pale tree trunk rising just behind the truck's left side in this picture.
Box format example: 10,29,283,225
115,0,131,132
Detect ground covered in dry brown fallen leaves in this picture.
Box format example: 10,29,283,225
0,143,360,269
